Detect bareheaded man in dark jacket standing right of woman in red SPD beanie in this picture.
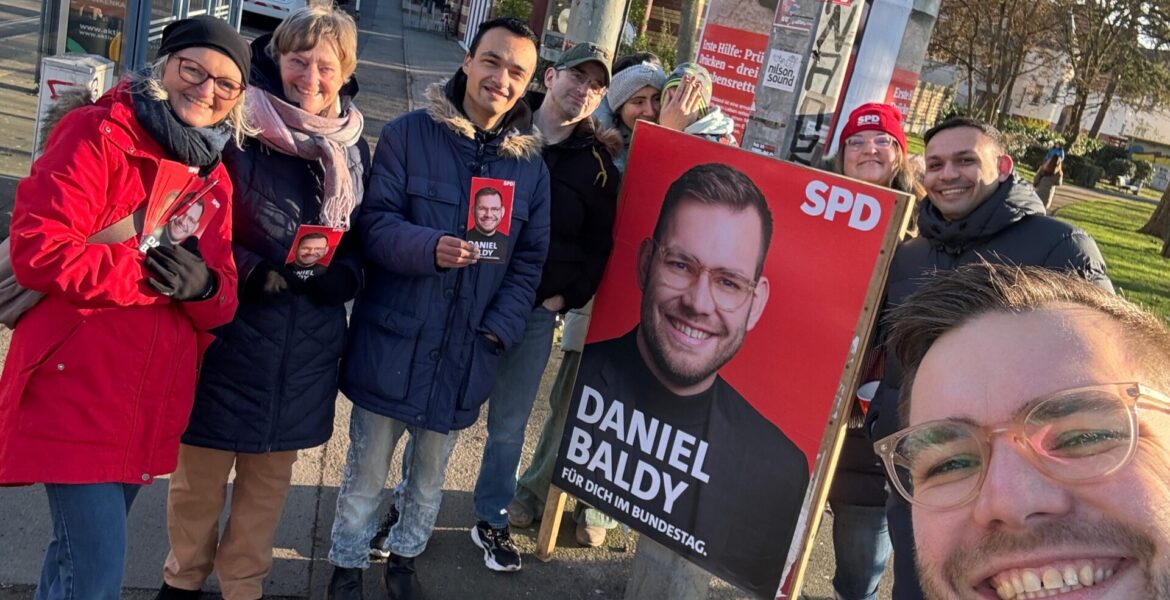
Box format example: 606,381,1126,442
867,118,1113,600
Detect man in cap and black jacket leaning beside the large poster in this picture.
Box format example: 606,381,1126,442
463,43,619,571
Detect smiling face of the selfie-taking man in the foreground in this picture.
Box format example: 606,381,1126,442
909,306,1170,600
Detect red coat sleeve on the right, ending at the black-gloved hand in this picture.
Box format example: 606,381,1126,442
179,165,240,331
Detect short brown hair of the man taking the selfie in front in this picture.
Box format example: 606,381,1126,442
885,261,1170,425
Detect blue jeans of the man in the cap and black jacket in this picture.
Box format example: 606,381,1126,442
475,306,557,527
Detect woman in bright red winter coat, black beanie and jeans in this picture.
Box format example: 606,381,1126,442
0,16,250,600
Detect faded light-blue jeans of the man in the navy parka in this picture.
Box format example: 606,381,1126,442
329,406,459,568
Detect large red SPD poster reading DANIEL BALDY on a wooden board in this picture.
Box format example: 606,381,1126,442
553,123,904,598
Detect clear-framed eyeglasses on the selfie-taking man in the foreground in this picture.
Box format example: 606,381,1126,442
874,382,1170,510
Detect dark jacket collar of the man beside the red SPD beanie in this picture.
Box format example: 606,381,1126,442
918,174,1045,254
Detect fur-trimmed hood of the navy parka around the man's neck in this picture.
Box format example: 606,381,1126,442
426,70,544,160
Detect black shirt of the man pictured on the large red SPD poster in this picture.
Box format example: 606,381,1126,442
553,329,808,598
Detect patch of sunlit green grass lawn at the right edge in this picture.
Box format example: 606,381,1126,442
1058,200,1170,320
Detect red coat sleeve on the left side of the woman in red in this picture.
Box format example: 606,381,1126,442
9,108,164,308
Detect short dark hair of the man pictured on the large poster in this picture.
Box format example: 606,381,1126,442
654,163,772,278
